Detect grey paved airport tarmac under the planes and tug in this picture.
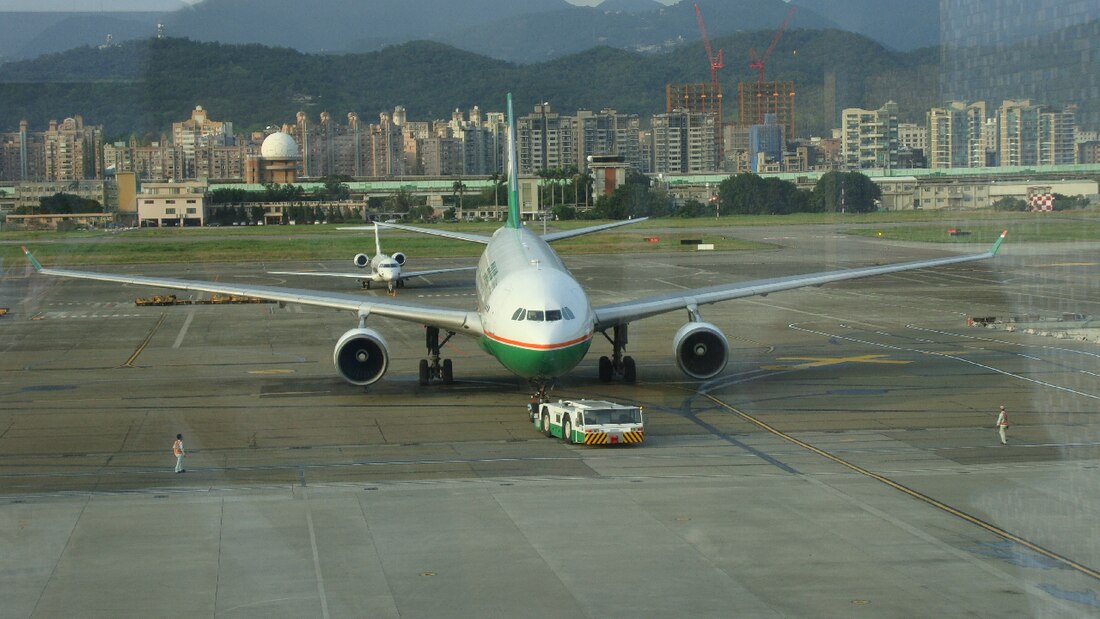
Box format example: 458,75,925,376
0,226,1100,618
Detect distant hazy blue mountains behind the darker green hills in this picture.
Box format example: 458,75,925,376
0,0,939,63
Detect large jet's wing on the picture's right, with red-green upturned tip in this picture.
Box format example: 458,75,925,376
593,230,1009,331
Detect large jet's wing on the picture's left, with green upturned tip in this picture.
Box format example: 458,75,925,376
23,247,483,335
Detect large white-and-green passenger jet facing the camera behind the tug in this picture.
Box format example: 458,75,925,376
23,93,1008,399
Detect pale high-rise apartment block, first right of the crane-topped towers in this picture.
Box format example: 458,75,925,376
840,101,898,169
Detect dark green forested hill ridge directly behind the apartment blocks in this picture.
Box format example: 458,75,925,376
0,30,938,137
